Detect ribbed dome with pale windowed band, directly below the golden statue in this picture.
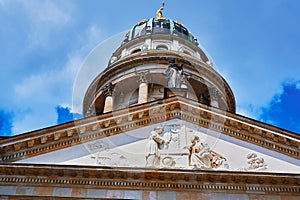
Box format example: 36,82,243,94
108,18,212,68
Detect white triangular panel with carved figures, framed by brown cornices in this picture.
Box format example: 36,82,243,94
18,119,300,173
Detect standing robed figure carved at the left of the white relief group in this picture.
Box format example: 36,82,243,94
146,127,164,167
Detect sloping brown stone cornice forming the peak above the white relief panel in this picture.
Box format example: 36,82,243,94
0,97,300,163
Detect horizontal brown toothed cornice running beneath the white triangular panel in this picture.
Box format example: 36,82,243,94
0,164,300,196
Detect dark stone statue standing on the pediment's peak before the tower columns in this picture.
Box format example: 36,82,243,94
165,59,183,88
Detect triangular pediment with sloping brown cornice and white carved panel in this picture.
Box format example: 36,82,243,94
2,98,300,173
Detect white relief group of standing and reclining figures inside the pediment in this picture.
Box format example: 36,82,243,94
145,124,229,169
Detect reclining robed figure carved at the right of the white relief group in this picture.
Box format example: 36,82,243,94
188,135,229,169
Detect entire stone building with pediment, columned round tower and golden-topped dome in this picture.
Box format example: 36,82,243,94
0,5,300,200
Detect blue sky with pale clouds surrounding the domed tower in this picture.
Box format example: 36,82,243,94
0,0,300,136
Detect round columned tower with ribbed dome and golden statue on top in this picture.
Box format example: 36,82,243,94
83,4,235,117
